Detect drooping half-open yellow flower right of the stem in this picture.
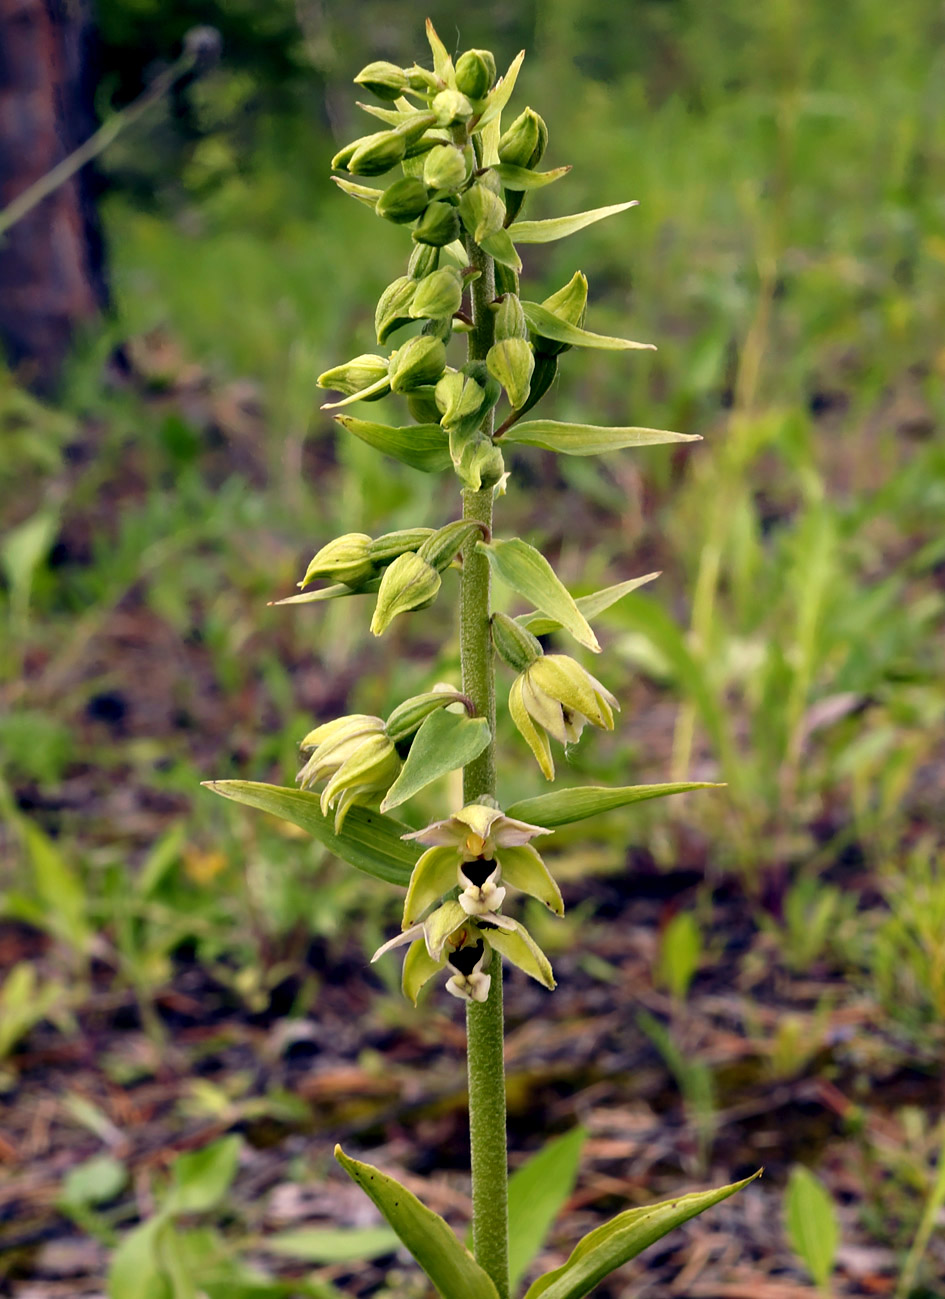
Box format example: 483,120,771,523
508,653,620,781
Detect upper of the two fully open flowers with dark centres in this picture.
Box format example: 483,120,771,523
403,803,564,926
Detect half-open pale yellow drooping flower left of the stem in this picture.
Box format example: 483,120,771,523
296,713,400,834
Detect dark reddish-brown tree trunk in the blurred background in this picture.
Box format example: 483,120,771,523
0,0,108,394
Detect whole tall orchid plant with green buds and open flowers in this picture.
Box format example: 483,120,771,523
211,22,745,1299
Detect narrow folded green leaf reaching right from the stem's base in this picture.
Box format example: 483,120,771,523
525,1172,760,1299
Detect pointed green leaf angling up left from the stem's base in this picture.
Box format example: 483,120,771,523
334,1146,498,1299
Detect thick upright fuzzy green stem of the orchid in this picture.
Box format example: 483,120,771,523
460,239,508,1299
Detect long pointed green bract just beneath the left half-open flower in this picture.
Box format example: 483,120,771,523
204,781,421,889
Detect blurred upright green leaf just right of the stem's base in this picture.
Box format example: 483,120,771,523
508,1128,588,1293
